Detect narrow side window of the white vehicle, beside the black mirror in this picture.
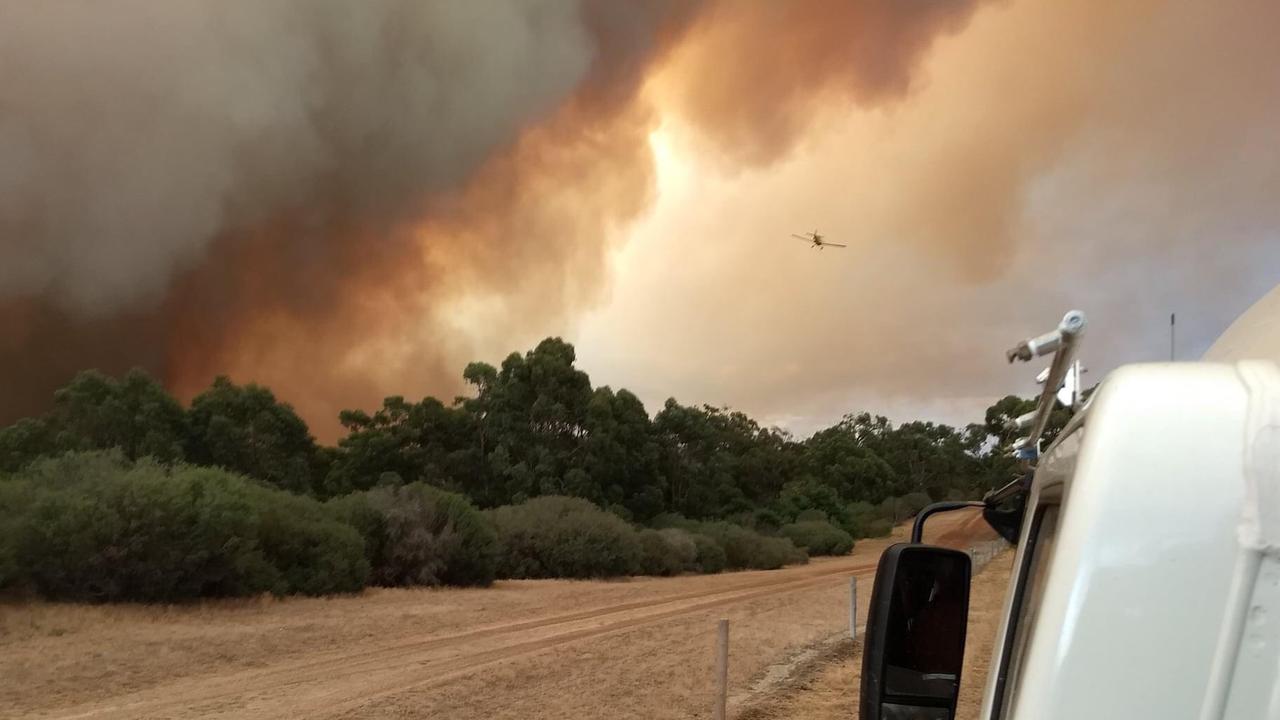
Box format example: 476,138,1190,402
992,505,1059,717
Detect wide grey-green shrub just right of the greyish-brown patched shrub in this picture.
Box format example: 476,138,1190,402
486,496,641,578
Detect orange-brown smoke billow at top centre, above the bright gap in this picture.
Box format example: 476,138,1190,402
654,0,974,165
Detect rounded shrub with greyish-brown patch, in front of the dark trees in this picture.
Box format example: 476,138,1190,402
328,483,497,585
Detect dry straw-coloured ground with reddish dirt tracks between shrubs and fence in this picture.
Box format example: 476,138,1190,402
0,514,982,719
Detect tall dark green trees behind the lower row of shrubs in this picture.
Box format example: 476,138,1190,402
0,338,1049,525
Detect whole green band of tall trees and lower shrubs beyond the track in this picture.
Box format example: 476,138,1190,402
0,338,1068,601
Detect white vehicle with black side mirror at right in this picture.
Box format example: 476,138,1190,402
861,298,1280,720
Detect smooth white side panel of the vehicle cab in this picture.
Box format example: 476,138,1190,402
982,363,1249,720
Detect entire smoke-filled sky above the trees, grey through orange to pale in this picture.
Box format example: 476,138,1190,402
0,0,1280,442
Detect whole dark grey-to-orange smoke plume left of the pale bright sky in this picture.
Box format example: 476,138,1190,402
0,0,973,433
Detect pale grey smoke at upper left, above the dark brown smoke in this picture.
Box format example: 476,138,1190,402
0,0,598,315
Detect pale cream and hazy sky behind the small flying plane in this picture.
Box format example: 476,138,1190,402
571,1,1280,434
